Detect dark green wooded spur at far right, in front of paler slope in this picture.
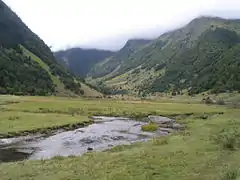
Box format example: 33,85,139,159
153,28,240,94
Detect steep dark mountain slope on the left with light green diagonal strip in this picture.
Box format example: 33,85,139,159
0,0,89,95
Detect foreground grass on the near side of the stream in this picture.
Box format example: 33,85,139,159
0,111,240,180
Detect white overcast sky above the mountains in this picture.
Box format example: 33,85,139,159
4,0,240,50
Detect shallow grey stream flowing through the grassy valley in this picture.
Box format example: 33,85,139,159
0,117,169,162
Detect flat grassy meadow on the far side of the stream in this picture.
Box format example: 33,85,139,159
0,96,226,137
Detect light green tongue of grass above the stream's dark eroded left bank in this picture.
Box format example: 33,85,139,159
0,111,89,137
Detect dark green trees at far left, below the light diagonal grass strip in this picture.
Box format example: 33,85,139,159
0,48,55,95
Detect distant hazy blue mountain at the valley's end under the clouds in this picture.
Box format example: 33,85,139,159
55,48,114,77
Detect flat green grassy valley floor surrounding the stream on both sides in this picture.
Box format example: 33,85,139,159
0,96,240,180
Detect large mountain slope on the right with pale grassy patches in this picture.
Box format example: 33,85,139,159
89,17,240,94
